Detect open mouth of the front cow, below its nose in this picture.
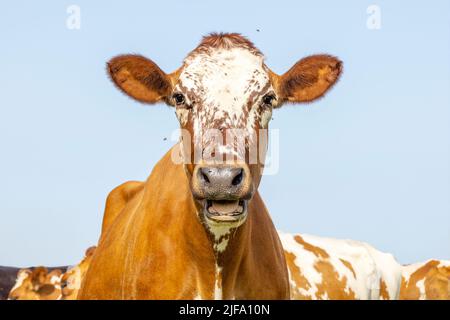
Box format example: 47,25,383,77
204,200,247,222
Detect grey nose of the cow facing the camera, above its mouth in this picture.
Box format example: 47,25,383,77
193,165,251,200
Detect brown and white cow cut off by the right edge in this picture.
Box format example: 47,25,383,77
400,259,450,300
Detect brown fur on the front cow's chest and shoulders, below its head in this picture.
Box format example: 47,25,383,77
79,151,289,299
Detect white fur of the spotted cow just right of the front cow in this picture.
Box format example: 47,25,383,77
279,232,401,299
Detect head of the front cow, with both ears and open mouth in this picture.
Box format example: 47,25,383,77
108,34,342,226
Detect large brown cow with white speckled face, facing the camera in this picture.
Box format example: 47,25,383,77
78,33,342,299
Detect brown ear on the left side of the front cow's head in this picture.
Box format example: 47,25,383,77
107,55,177,103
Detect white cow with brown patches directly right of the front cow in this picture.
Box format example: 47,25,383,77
279,232,401,300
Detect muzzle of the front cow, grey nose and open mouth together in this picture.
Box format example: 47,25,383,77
191,163,253,222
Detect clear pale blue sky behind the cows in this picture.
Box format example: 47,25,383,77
0,0,450,266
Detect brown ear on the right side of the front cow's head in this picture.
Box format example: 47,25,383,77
274,55,342,102
